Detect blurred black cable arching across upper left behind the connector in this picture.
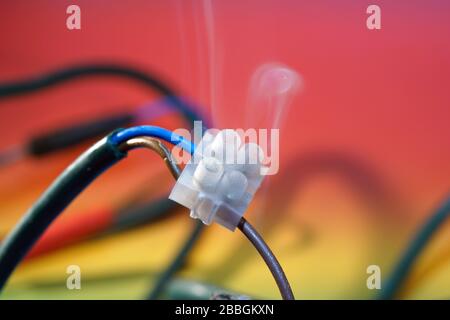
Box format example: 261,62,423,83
0,63,201,126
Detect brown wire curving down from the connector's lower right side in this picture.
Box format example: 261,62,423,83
238,217,295,300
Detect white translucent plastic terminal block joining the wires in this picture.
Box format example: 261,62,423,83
169,129,264,231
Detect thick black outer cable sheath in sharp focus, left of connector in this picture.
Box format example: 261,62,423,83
0,138,126,291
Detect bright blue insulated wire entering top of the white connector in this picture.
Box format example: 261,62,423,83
109,126,195,154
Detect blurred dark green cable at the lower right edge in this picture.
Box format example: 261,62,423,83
378,198,450,300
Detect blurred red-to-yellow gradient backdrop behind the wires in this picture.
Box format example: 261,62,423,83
0,0,450,299
